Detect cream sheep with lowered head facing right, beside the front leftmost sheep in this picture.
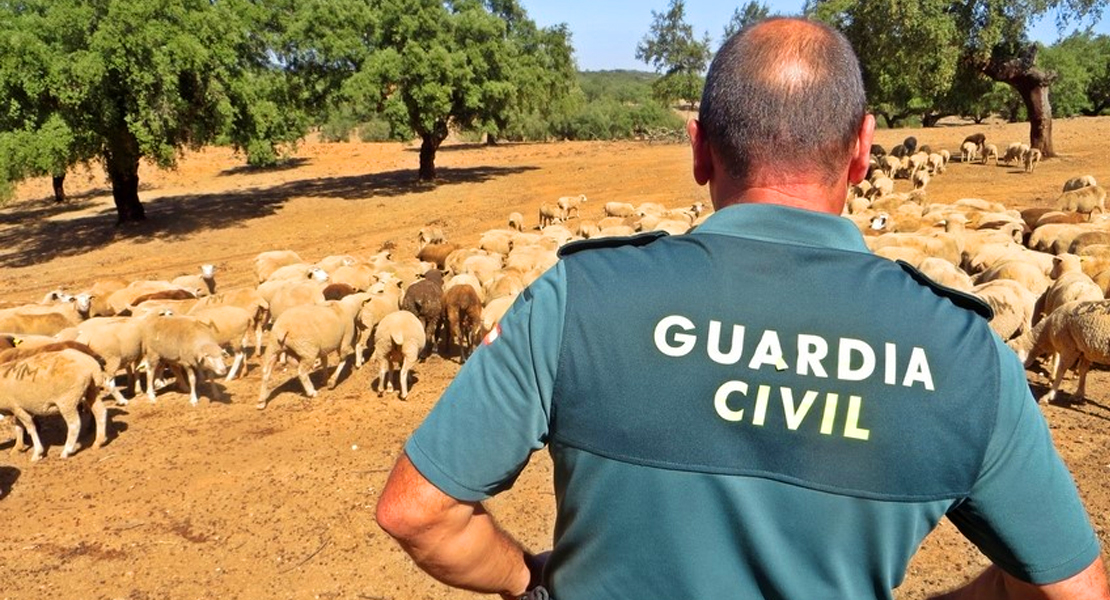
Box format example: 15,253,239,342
139,315,228,406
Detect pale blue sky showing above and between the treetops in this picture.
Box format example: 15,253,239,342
521,0,1110,71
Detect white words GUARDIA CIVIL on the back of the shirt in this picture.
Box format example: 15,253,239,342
654,315,936,440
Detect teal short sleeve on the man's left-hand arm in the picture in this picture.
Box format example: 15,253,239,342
405,263,566,501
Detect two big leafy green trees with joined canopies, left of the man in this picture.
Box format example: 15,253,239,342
0,0,575,215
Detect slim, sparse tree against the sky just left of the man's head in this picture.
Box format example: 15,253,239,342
636,0,712,104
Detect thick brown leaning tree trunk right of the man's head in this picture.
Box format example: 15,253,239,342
983,44,1058,157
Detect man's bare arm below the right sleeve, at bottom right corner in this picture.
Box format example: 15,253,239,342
932,558,1110,600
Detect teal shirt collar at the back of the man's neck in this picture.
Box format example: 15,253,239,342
693,204,870,252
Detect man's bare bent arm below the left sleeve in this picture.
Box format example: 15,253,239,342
376,454,532,598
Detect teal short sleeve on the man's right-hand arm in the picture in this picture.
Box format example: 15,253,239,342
948,339,1099,584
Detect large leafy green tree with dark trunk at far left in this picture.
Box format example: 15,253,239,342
0,0,303,215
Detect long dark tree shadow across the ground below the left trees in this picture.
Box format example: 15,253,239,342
0,165,538,267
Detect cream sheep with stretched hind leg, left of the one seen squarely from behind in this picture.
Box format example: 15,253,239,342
258,292,371,409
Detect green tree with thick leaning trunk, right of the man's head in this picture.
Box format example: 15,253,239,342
805,0,1107,155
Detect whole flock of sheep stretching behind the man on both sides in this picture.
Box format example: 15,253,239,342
0,134,1110,460
